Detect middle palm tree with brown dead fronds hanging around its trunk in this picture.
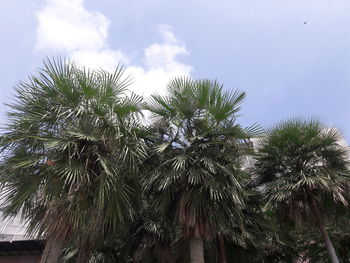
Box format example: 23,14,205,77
145,78,257,263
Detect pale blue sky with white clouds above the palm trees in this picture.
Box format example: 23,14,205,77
0,0,350,142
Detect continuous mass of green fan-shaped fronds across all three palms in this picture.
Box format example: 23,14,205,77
0,60,350,263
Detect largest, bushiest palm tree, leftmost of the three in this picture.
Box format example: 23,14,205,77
0,60,145,262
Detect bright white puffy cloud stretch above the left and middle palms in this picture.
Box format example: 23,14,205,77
36,0,192,96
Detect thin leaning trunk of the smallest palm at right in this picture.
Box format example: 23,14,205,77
311,198,339,263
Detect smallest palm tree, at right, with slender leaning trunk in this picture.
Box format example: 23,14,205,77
256,119,349,263
